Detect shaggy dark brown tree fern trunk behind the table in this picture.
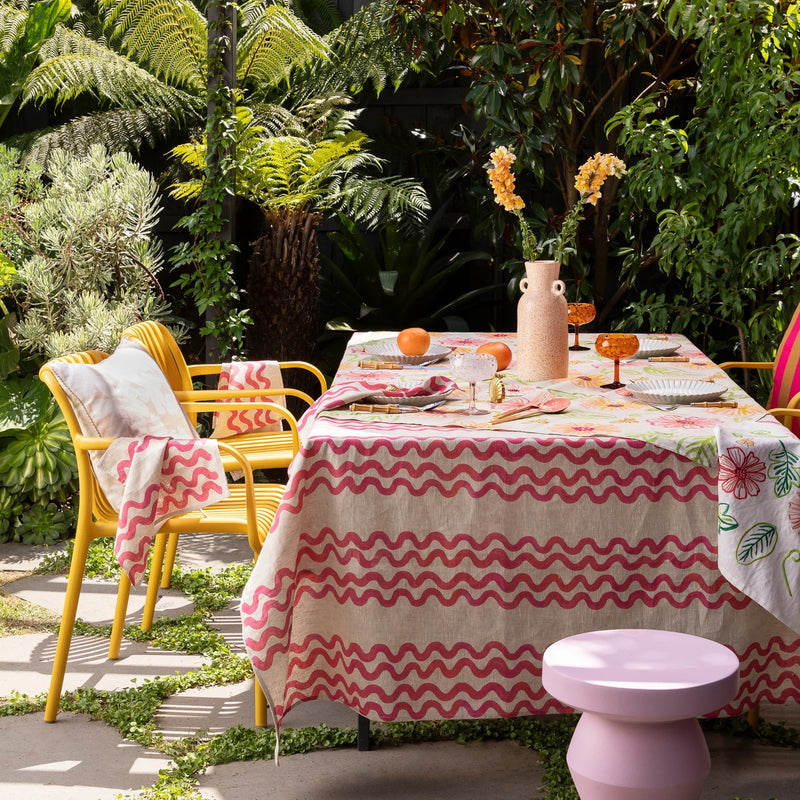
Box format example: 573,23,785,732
246,206,320,368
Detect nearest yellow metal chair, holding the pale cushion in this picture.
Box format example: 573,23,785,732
39,351,284,726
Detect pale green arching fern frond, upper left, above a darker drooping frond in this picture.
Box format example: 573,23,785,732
22,28,201,121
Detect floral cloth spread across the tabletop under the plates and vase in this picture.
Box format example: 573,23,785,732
314,332,786,468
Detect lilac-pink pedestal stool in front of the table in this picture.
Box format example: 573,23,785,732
542,629,739,800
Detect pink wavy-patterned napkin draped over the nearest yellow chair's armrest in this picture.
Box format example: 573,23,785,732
102,436,229,586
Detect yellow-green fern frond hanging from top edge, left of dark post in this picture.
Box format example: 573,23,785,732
99,0,208,93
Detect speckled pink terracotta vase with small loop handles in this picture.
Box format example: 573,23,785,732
517,261,569,381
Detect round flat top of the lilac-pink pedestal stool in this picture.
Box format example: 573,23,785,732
542,629,739,720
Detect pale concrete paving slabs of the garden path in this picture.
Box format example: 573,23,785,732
0,536,800,800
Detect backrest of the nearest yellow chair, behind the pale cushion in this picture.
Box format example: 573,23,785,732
39,350,119,526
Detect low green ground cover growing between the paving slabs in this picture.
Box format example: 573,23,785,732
0,539,800,800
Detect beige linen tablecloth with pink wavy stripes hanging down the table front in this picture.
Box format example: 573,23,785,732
242,334,800,723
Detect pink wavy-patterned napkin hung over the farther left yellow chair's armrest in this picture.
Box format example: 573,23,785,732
211,361,286,439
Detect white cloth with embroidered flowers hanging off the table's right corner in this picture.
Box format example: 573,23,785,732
716,425,800,632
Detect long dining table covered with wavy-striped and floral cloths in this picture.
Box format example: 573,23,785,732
241,331,800,729
